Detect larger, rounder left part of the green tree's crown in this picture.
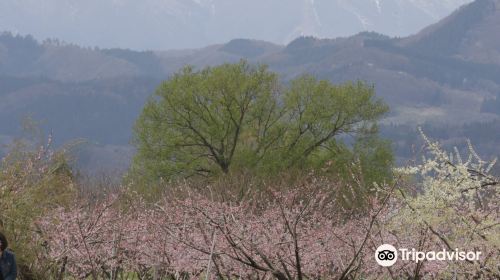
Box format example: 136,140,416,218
134,60,278,178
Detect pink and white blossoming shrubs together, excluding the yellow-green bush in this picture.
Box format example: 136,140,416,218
7,131,500,280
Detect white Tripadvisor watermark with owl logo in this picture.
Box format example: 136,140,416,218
375,244,481,266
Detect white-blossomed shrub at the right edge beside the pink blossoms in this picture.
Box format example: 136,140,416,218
391,131,500,279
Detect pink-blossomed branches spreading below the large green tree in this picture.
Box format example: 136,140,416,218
41,178,398,279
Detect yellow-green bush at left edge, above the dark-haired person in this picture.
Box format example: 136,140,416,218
0,137,74,278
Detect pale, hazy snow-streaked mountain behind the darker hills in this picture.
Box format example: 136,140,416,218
0,0,471,50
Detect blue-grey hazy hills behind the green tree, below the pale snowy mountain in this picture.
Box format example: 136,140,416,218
0,0,500,172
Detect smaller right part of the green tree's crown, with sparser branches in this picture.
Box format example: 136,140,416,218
276,76,388,172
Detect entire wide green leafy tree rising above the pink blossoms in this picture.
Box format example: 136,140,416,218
131,61,388,182
